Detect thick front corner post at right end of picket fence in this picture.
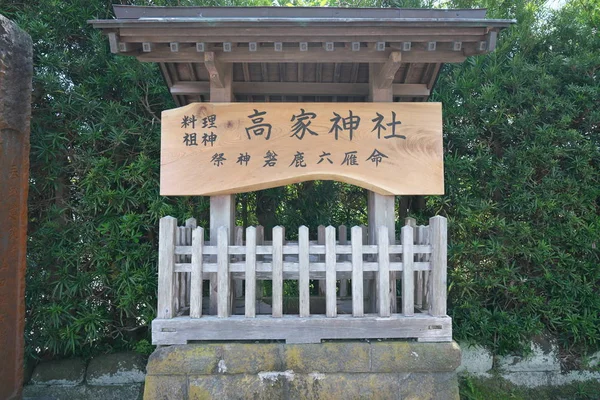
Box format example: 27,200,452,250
429,215,448,316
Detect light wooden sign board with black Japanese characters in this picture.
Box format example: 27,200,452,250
160,103,444,196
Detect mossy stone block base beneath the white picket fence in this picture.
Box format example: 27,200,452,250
144,341,460,400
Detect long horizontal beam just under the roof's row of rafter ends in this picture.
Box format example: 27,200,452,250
136,47,468,63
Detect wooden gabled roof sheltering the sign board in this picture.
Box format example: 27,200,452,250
89,5,515,106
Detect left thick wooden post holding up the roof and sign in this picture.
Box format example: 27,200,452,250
204,52,235,314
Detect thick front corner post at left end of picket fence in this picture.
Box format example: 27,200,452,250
156,217,177,318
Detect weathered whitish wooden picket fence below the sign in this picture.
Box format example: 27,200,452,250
152,216,452,345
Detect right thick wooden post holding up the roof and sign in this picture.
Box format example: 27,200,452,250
366,63,400,312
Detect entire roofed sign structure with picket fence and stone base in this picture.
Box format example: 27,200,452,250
90,5,514,399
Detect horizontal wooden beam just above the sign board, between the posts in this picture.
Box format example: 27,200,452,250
171,81,430,97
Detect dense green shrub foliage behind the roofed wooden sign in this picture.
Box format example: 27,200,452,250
0,0,600,357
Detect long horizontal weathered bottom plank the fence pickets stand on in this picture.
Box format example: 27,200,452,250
152,314,452,345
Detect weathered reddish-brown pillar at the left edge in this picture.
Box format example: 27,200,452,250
0,15,33,399
